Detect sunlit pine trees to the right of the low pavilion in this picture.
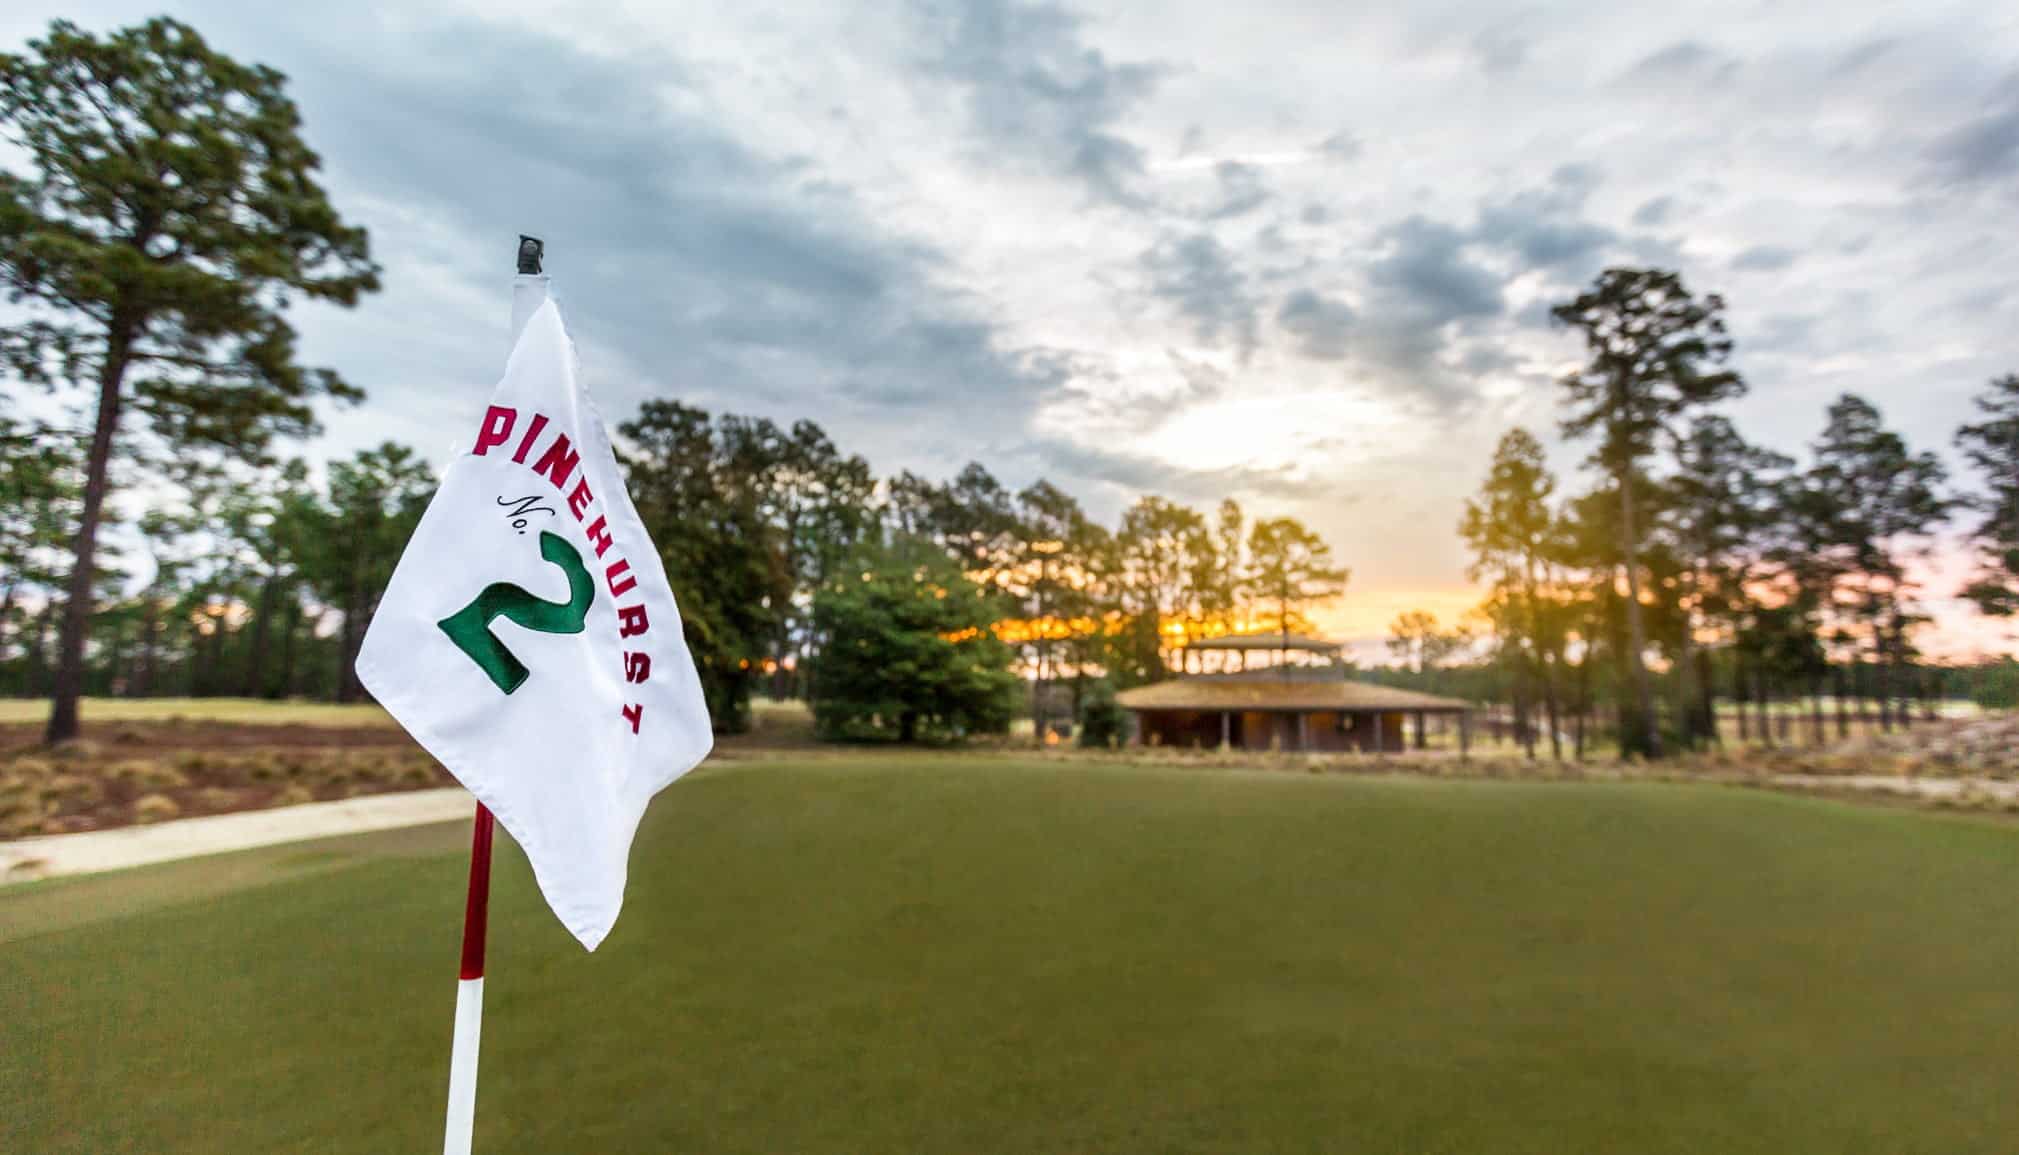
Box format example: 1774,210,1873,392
1421,269,2019,757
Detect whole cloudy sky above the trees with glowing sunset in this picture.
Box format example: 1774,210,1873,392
0,0,2019,648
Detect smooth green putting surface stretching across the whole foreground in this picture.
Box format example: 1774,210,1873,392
0,757,2019,1155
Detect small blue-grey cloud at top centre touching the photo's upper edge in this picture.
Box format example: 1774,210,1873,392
919,0,1159,208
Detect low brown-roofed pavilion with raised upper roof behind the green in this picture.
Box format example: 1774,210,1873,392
1117,634,1472,753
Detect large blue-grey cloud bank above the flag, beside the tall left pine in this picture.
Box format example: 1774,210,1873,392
146,10,1060,474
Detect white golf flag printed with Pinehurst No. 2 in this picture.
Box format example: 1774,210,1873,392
357,301,713,951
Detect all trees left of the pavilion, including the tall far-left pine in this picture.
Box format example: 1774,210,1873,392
0,18,1345,741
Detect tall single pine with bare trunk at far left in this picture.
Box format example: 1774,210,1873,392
0,18,378,741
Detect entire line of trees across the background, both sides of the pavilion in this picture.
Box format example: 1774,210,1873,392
0,18,2019,755
